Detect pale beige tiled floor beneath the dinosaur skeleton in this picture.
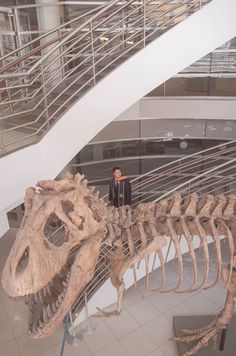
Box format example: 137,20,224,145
0,230,229,356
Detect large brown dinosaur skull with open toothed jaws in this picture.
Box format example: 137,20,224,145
2,175,105,337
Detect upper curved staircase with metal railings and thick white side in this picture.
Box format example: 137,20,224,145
0,0,236,231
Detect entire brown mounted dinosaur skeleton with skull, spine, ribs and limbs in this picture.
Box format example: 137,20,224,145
2,173,236,356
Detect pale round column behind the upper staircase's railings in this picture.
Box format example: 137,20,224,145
36,0,62,88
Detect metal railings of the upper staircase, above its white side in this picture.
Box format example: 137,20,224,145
0,0,211,155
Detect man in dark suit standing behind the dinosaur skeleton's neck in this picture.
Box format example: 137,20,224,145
109,167,131,208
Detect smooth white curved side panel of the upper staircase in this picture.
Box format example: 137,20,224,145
0,0,236,225
